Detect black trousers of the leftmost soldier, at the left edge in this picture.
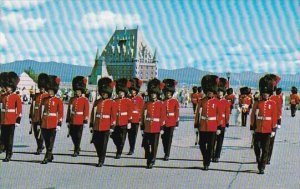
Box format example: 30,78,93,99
1,124,16,158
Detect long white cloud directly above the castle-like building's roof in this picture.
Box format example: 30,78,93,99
77,11,142,29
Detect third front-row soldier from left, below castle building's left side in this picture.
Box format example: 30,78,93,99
90,77,117,167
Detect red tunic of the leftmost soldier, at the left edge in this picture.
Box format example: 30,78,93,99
1,93,22,125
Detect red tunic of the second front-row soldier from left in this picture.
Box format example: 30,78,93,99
41,96,64,129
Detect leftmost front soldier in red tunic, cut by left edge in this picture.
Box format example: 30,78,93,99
1,72,22,162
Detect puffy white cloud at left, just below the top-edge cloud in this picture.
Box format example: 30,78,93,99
1,13,46,31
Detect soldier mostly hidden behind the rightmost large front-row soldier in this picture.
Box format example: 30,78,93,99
265,74,283,164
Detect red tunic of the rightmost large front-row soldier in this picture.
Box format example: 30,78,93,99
250,100,277,133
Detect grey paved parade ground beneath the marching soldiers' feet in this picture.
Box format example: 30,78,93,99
0,105,300,189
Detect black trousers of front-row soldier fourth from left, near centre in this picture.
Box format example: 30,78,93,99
143,133,159,165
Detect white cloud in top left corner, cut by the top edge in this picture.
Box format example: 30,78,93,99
2,0,46,9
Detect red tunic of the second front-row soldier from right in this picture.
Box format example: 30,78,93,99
195,97,221,132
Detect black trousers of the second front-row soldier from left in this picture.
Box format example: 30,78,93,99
42,128,56,160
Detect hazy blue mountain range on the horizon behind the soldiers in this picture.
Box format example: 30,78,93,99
0,60,300,90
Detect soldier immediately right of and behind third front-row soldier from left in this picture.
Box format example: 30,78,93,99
112,78,132,159
